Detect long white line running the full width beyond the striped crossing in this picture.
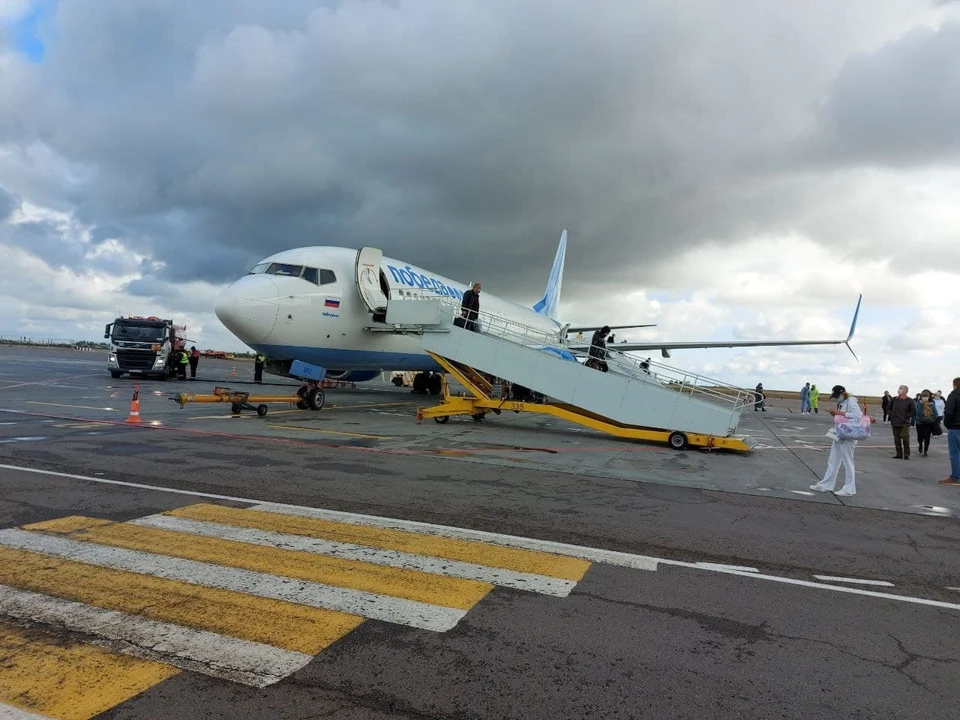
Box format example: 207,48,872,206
0,464,960,611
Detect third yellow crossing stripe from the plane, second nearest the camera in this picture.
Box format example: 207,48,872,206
0,547,363,655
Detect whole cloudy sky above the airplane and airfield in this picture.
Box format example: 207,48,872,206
0,0,960,392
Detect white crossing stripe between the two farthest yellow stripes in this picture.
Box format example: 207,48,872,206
130,515,576,597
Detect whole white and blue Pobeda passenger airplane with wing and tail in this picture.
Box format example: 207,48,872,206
214,230,863,394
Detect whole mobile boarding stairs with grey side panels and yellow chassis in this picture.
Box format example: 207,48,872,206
387,298,756,452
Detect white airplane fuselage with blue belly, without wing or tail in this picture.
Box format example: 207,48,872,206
215,247,562,379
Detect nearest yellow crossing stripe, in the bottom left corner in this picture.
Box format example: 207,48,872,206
0,623,180,720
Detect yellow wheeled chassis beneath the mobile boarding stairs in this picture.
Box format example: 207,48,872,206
417,353,750,452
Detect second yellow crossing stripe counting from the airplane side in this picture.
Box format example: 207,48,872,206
24,517,493,610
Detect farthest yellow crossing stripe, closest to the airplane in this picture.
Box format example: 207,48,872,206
164,504,590,580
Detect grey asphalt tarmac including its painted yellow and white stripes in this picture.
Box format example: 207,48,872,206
0,348,960,719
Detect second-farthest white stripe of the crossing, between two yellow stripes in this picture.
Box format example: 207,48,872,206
0,529,466,632
